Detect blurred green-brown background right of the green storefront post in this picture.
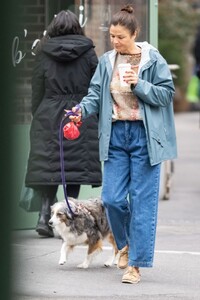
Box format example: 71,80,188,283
158,0,200,112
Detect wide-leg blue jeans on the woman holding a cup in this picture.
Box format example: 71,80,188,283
102,121,160,267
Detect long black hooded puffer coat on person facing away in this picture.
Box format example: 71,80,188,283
25,35,102,187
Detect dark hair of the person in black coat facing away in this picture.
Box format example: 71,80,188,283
46,10,84,37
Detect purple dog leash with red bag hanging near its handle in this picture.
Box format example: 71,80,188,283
59,104,81,218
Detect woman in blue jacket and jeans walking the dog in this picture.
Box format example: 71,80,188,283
71,6,177,283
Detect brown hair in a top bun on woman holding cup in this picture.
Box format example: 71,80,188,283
110,5,139,35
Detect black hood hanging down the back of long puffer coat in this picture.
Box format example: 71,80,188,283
42,34,94,62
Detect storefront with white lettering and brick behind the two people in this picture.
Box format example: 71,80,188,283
12,0,153,124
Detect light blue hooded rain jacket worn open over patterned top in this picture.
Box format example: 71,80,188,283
80,42,177,165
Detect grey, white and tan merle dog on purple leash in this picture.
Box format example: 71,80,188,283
49,198,118,268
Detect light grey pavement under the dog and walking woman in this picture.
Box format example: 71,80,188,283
12,112,200,300
